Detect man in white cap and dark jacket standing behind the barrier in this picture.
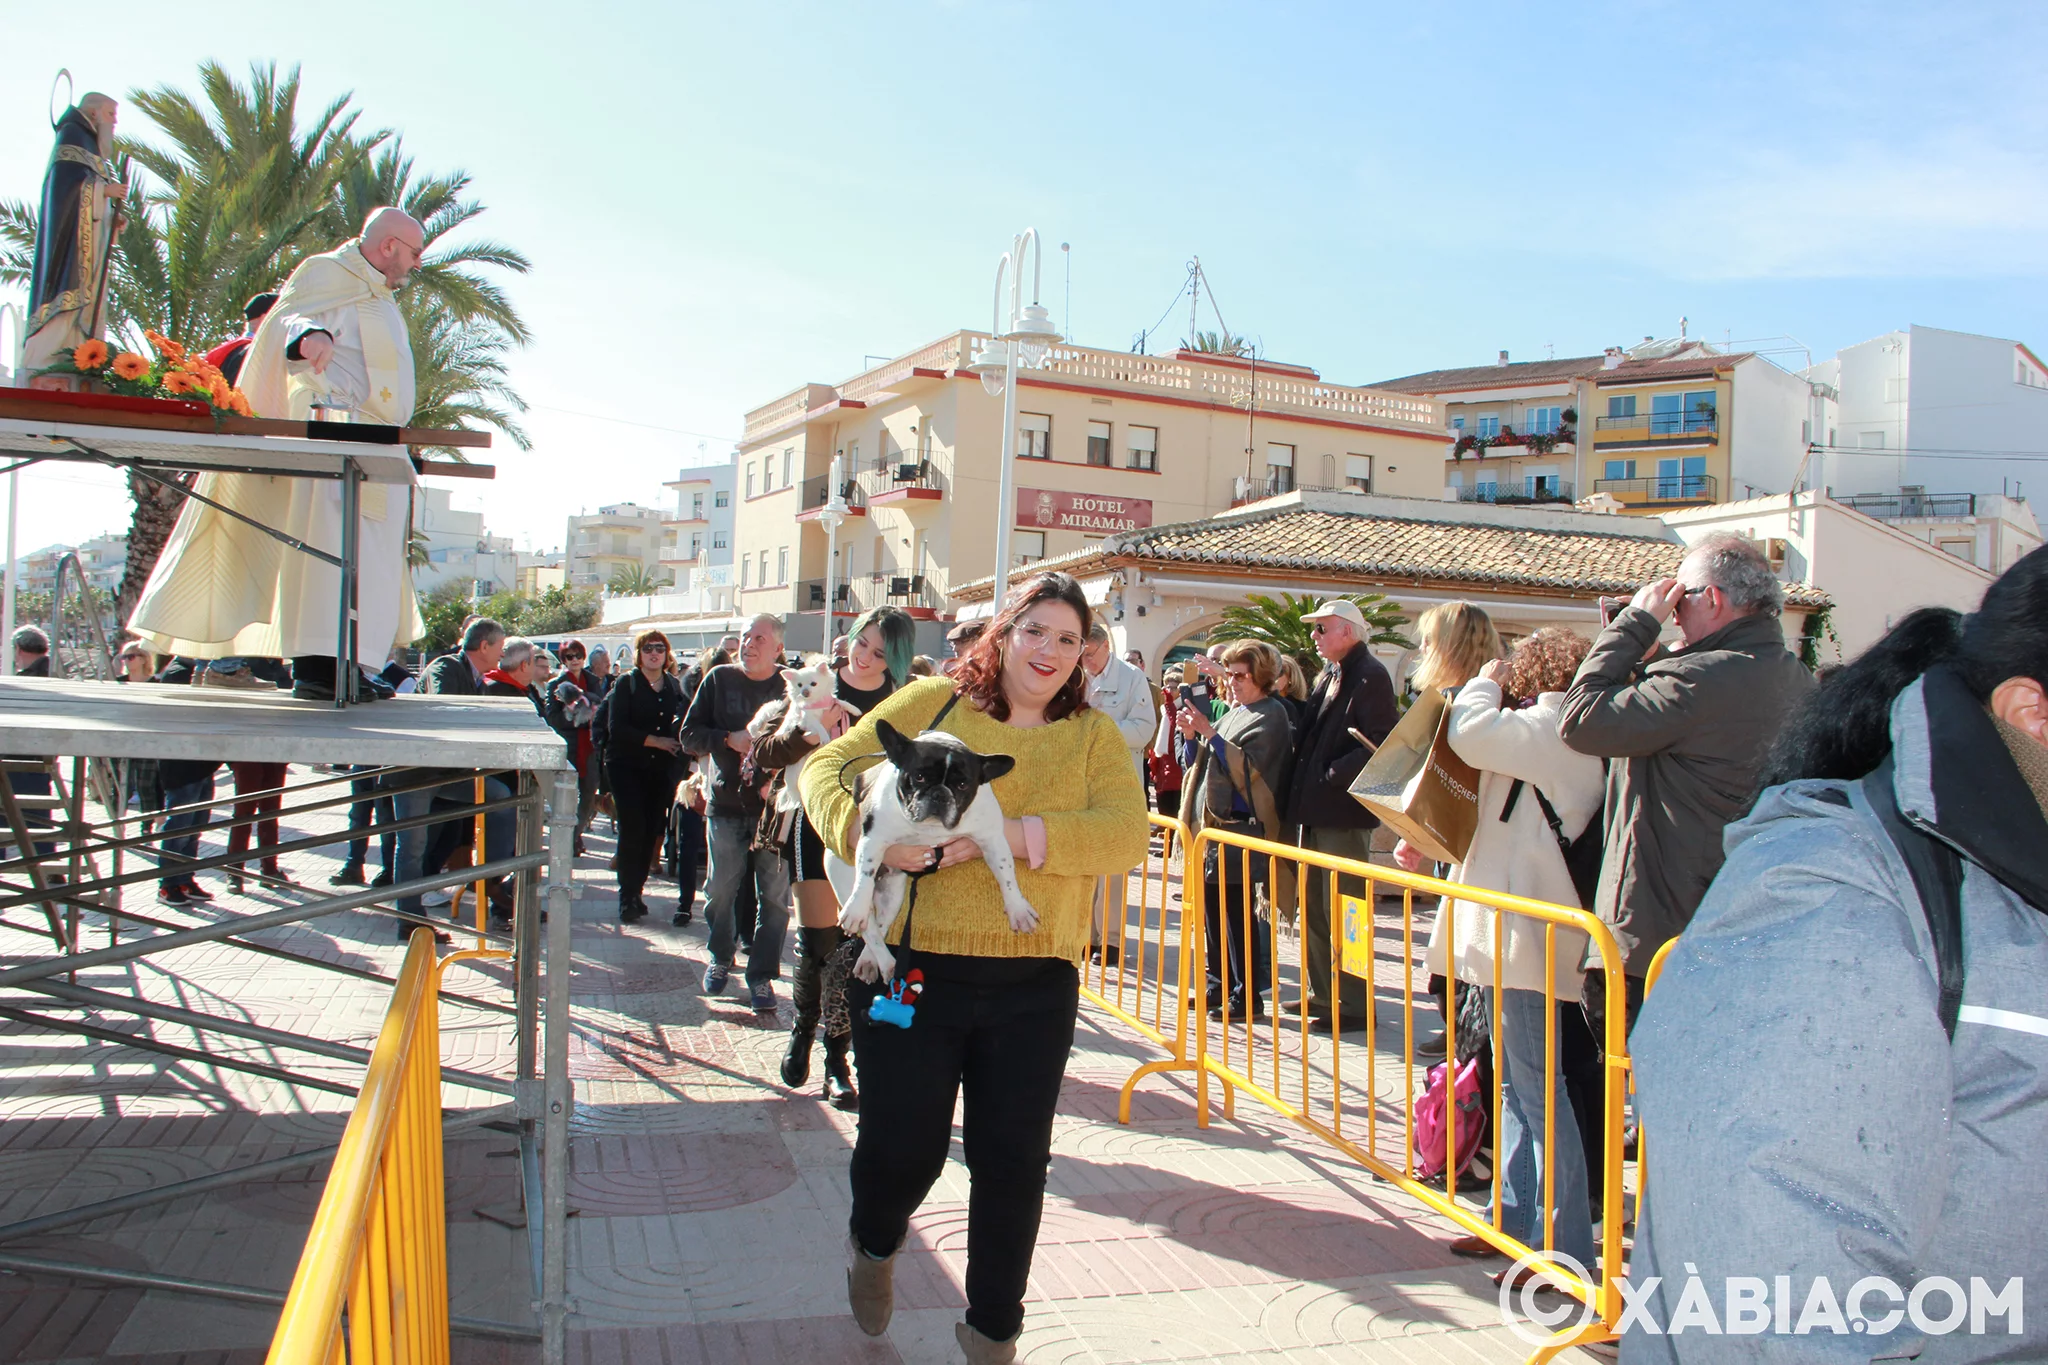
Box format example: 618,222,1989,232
1284,598,1399,1027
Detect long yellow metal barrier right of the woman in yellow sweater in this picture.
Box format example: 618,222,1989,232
1114,817,1628,1361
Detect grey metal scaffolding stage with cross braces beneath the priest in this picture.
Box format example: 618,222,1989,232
0,677,575,1365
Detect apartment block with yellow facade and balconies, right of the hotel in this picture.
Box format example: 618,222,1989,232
1374,338,1823,514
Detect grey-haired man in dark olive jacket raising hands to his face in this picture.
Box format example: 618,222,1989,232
1559,532,1812,1019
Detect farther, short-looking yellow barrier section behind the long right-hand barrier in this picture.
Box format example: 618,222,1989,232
1081,812,1194,1124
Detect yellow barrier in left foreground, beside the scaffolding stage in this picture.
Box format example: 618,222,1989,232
266,929,506,1365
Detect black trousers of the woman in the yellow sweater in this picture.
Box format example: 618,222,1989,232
848,954,1081,1340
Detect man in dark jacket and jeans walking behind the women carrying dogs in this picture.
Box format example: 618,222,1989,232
682,616,788,1009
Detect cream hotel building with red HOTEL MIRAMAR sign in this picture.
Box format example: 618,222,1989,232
733,332,1444,616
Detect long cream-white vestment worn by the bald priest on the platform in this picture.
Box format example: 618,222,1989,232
129,241,426,669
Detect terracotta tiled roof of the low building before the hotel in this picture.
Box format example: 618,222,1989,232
952,505,1829,606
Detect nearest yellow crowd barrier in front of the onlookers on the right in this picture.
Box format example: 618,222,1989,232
1083,814,1628,1361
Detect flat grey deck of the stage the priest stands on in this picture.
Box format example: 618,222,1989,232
0,677,569,772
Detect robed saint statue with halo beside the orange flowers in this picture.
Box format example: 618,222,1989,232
23,92,127,389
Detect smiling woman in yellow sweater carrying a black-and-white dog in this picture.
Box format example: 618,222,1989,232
803,573,1147,1363
